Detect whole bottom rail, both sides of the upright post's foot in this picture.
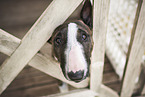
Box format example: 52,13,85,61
42,85,119,97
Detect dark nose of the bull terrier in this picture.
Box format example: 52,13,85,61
68,70,84,82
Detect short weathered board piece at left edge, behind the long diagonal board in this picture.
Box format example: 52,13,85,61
0,29,21,56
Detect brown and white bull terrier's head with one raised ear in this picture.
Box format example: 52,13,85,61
51,0,93,82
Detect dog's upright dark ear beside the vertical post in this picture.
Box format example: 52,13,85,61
80,0,93,29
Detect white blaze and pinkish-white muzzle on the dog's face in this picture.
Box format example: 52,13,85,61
65,23,87,75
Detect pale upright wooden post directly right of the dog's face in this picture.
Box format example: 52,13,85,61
90,0,110,92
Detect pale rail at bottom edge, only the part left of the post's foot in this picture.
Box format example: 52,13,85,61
47,89,97,97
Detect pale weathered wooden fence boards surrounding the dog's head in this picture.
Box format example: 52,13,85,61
0,0,145,97
